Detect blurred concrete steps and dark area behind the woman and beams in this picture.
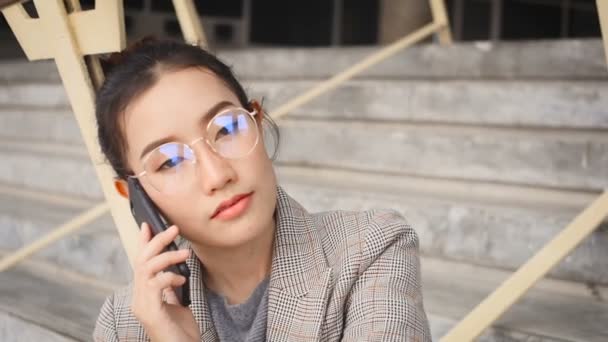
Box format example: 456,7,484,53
0,0,608,341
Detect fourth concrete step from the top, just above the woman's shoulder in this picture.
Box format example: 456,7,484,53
0,160,608,284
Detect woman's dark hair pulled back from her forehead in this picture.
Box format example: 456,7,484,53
95,38,279,179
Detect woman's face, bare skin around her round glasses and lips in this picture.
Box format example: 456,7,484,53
124,68,276,247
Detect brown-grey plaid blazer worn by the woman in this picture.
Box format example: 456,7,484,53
93,187,431,342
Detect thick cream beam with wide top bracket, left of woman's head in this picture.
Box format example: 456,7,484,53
3,0,139,264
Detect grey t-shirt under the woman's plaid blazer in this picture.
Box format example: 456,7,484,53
206,278,269,342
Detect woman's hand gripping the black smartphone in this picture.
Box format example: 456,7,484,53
131,223,200,342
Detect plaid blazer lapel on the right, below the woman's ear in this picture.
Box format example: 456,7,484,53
266,187,331,341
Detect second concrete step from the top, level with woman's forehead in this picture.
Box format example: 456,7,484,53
0,80,608,130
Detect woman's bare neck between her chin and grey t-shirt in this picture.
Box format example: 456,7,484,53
192,219,275,304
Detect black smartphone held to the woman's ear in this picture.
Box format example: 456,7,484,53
127,177,190,306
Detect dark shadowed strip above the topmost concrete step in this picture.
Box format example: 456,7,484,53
0,0,601,52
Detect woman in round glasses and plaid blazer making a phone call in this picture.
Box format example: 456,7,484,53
94,41,431,342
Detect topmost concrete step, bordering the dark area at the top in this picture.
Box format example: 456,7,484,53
0,39,608,83
